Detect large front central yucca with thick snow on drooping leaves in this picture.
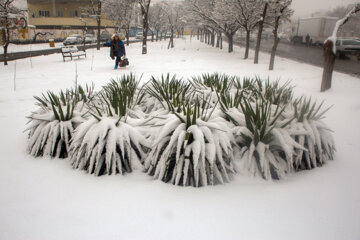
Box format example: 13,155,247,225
145,93,235,187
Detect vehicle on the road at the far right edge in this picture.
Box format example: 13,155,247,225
336,38,360,59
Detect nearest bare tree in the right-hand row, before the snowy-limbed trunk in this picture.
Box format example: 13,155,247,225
269,0,294,70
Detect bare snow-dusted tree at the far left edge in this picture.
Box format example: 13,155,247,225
0,0,24,65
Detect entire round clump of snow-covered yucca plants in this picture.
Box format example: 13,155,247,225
27,73,335,187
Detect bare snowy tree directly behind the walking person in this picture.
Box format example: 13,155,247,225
104,0,136,45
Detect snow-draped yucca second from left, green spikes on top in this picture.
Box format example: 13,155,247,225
70,74,148,176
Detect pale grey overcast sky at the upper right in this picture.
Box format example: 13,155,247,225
292,0,360,17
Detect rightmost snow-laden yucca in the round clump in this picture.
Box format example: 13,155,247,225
290,97,335,170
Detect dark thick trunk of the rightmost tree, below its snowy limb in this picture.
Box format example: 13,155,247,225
320,40,336,92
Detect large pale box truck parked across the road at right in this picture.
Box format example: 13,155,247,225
291,17,338,45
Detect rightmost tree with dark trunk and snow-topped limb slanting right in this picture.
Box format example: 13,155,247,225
320,2,360,92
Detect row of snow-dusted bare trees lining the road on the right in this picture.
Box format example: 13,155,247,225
185,0,293,70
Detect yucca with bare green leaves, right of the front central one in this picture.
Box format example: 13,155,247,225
222,92,305,180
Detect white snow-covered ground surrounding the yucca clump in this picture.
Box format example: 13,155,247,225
0,39,360,240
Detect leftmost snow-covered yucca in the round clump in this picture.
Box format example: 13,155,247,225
26,86,93,158
